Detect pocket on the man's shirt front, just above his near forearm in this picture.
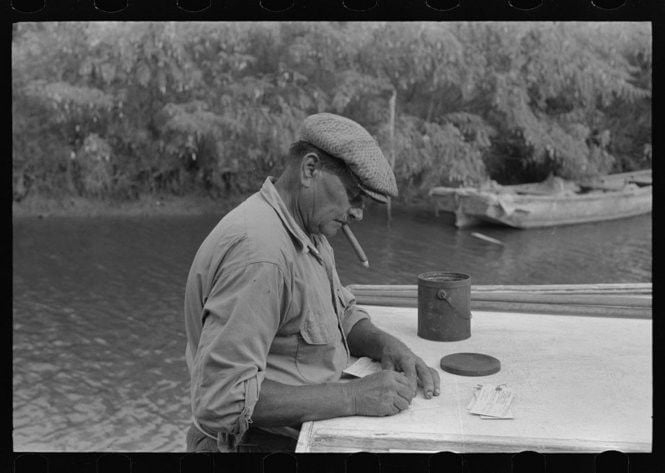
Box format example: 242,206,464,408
296,311,337,384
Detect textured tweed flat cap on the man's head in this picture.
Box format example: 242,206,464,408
299,113,397,202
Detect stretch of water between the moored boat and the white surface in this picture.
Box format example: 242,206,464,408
333,209,651,284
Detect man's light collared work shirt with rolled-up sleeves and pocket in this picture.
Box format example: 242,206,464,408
185,178,369,448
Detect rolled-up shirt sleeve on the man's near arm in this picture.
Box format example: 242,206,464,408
191,262,288,448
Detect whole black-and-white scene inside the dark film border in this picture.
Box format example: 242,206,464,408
11,21,653,453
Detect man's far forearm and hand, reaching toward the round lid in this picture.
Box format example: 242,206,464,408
347,319,441,399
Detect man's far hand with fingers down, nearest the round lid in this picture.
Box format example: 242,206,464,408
381,339,441,399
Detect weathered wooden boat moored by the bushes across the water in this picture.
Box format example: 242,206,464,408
429,169,652,228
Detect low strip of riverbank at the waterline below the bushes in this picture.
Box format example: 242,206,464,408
12,195,432,218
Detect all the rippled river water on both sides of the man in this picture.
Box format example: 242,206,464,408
13,208,652,451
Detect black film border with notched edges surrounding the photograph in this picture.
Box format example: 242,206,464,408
2,0,665,473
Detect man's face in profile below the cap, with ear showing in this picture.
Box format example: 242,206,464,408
308,159,364,238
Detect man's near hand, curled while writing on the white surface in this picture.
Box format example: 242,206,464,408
344,371,416,416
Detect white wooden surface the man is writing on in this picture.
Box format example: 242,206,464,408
296,306,652,452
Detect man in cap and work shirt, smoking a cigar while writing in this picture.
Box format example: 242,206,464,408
185,113,440,452
